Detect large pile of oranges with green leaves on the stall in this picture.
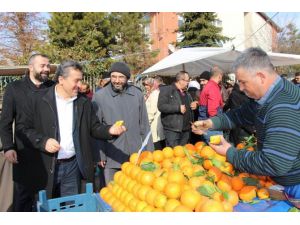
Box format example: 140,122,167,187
100,142,274,212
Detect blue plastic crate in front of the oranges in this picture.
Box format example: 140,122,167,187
37,183,112,212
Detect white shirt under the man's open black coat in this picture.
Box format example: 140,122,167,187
55,90,77,159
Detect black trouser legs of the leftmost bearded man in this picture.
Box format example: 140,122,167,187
13,182,37,212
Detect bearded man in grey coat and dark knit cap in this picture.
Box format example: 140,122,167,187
93,62,153,184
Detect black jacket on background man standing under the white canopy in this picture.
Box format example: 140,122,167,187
157,84,193,132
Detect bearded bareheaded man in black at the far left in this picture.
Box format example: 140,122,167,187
0,54,54,212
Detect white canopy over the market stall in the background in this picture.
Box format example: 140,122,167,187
142,47,300,76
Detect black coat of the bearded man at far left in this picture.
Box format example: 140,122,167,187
0,76,54,192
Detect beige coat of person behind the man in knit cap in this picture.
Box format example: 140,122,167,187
146,90,165,142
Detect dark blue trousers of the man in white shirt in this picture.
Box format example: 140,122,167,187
53,157,81,198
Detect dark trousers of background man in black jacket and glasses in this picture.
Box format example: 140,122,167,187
164,129,191,148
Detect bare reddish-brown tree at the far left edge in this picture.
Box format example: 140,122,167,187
0,12,46,65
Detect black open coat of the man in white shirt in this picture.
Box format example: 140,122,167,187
17,86,113,196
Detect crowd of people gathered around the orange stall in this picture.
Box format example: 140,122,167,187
0,48,300,212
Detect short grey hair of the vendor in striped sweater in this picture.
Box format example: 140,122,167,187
232,47,274,73
